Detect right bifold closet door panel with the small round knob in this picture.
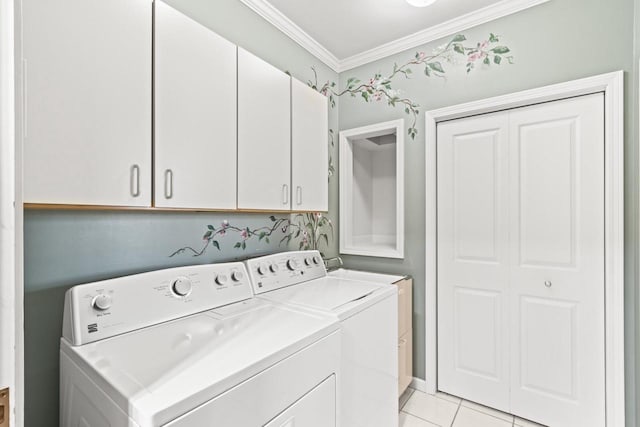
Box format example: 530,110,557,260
509,94,605,427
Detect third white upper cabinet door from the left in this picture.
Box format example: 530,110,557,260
238,48,291,210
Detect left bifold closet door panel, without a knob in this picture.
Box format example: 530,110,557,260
437,113,509,411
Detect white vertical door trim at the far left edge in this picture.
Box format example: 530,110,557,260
0,1,20,425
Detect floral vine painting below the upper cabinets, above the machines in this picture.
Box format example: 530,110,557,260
169,212,333,257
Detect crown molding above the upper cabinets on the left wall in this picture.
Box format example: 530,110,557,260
240,0,340,72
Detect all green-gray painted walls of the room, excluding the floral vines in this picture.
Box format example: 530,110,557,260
25,0,640,427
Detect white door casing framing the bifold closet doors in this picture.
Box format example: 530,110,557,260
425,71,625,427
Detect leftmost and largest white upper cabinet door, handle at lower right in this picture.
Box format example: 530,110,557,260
23,0,152,206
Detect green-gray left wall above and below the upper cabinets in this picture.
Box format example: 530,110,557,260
24,0,338,427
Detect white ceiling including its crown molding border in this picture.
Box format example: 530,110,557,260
241,0,549,71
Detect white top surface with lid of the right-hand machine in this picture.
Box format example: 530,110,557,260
262,277,396,317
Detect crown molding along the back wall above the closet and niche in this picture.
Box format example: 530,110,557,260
339,0,549,72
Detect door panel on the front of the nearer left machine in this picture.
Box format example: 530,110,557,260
265,375,336,427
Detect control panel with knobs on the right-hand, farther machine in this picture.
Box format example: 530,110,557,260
245,251,327,295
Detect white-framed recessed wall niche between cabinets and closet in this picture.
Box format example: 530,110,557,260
340,119,404,258
